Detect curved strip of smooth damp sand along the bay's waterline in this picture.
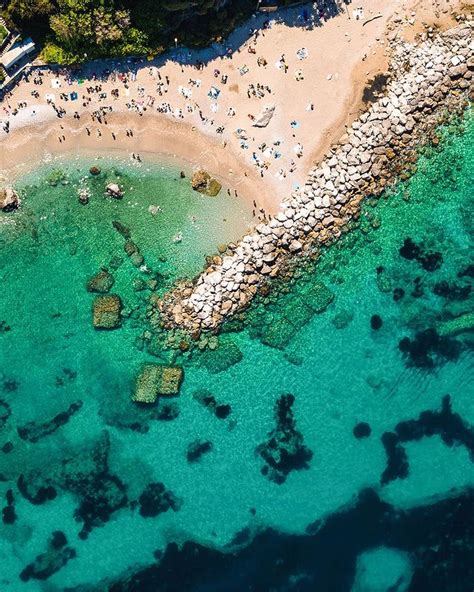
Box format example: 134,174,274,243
1,113,272,211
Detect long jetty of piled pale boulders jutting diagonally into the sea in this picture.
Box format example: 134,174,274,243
159,23,474,333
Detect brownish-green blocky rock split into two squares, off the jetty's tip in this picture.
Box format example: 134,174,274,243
132,364,184,403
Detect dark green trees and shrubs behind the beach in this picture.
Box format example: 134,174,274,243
2,0,270,65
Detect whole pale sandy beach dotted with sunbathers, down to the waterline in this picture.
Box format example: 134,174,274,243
0,0,463,213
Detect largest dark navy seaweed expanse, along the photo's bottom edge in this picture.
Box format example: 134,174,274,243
107,489,474,592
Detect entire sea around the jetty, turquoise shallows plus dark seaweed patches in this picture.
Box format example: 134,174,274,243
0,113,474,592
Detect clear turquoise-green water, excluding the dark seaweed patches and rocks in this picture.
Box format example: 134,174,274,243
0,116,474,591
